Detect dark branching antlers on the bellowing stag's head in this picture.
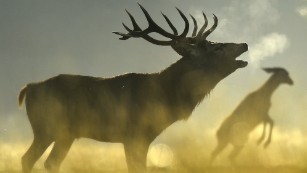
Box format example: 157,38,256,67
113,3,218,54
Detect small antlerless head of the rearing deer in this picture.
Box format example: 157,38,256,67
263,67,293,85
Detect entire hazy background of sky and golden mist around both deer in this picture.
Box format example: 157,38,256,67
0,0,307,172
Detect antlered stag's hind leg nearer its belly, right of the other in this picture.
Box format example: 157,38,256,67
44,138,74,173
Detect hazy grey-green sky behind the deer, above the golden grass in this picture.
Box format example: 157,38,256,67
0,0,307,145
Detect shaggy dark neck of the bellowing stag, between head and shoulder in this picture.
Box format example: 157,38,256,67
158,57,219,119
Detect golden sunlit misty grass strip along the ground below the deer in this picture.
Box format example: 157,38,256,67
0,137,307,173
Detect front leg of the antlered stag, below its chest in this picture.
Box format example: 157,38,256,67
124,143,149,173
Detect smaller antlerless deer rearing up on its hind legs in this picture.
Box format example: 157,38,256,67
210,68,293,164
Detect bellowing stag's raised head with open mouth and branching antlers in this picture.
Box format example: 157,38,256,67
113,4,248,78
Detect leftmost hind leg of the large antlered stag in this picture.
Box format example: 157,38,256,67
21,135,52,173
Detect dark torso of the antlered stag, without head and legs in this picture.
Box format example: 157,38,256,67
20,65,218,142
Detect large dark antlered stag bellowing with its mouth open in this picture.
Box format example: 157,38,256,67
19,4,248,173
